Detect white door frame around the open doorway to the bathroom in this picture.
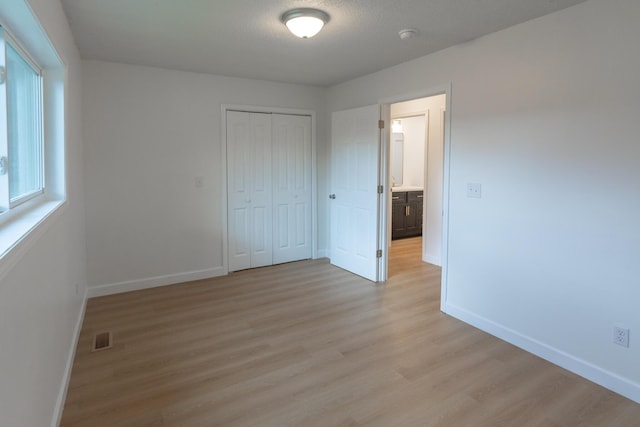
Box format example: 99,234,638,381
378,83,452,311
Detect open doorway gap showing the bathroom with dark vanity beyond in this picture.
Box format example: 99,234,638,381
387,93,447,275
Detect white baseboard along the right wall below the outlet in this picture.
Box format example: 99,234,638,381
443,304,640,403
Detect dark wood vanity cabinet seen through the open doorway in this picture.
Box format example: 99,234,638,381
391,191,424,239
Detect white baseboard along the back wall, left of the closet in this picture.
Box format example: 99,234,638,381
88,267,227,298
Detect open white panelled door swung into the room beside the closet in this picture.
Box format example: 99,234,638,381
329,105,380,282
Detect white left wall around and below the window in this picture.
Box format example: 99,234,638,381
0,0,86,426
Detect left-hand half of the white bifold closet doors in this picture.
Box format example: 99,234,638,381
227,111,273,271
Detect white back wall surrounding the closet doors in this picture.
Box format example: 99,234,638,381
83,61,327,295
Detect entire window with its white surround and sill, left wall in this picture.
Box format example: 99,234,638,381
0,12,63,264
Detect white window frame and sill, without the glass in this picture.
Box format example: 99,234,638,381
0,10,68,279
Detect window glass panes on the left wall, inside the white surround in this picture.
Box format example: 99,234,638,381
0,31,44,211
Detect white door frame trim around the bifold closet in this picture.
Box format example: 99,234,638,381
220,104,318,274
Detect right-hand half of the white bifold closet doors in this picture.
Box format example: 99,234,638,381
271,114,312,264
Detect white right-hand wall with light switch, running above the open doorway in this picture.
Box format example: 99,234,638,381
328,0,640,401
